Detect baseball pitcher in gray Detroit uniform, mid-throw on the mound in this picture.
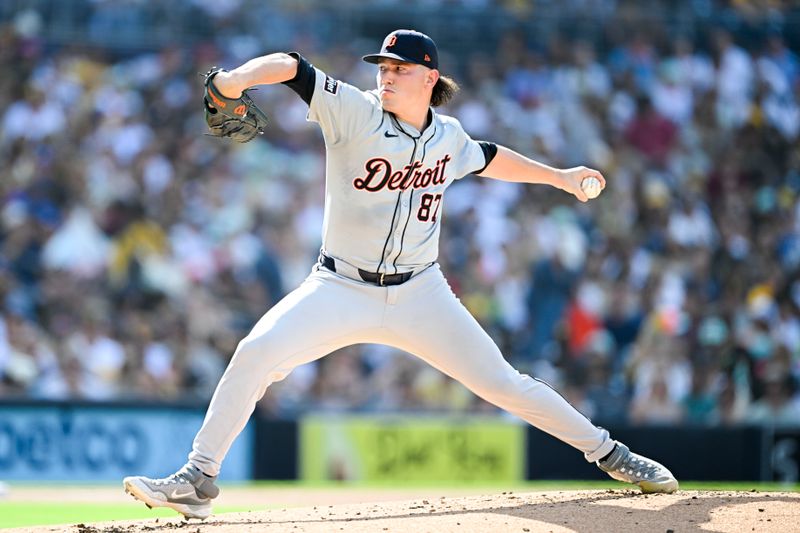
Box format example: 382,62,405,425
124,30,678,519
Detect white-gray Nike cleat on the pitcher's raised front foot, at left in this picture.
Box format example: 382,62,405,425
122,463,219,520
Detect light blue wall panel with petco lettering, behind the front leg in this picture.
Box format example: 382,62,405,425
0,403,254,483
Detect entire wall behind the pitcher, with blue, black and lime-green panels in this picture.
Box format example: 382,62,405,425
0,403,800,484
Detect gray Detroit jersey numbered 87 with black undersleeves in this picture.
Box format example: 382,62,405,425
289,55,492,274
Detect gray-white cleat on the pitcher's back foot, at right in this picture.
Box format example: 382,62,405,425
597,442,678,494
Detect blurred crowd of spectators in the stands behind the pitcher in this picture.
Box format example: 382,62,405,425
0,2,800,425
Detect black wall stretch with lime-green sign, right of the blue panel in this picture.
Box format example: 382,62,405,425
262,416,800,483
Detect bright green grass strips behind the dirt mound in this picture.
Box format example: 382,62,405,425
0,481,800,528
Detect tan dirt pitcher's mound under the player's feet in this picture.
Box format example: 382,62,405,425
8,490,800,533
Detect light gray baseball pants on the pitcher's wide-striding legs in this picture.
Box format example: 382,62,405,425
189,264,614,476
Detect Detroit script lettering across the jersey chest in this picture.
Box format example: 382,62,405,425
353,154,451,192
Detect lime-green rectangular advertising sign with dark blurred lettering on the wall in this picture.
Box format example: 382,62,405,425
300,416,525,482
